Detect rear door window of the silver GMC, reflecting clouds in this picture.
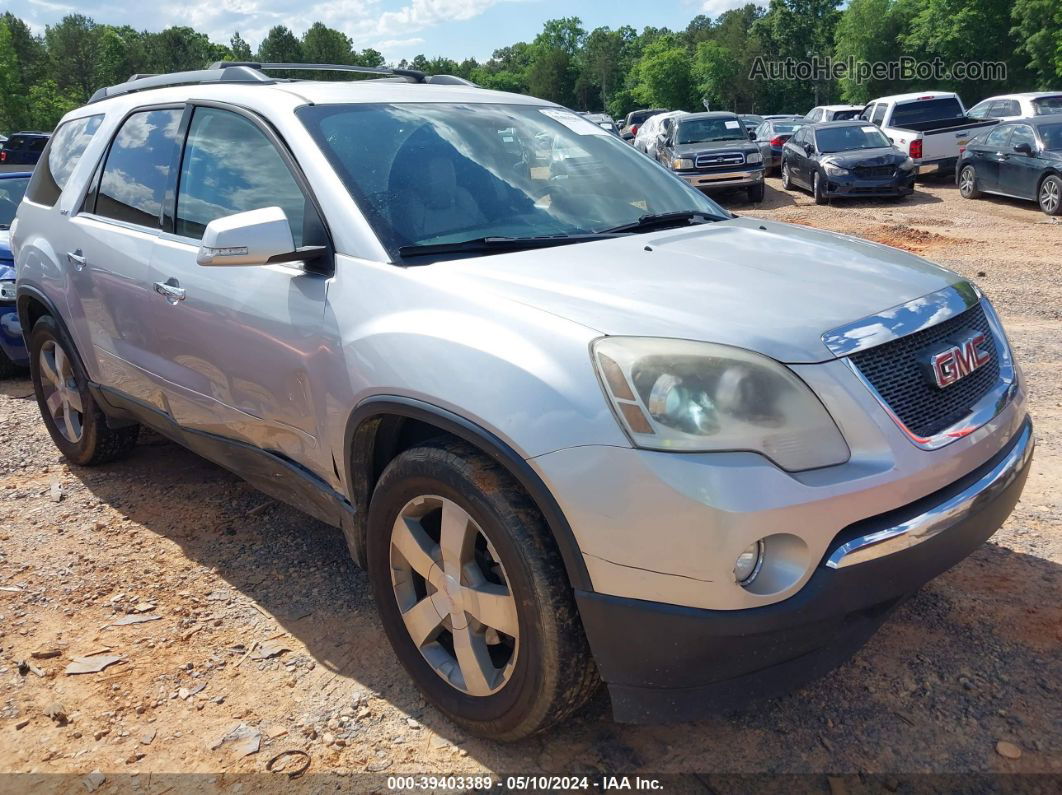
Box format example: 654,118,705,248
96,108,183,229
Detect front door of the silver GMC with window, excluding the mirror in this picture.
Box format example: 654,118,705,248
150,105,340,469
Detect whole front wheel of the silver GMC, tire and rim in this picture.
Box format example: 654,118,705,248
367,440,598,741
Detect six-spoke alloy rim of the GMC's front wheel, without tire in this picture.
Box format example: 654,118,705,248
390,496,519,696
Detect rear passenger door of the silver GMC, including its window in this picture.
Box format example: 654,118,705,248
68,105,184,409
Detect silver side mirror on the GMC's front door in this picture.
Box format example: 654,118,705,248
195,207,324,266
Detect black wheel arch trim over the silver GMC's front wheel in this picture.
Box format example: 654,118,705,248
344,396,590,590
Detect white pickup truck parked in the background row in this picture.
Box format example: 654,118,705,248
859,91,997,174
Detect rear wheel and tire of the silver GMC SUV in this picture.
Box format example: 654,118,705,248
27,315,140,467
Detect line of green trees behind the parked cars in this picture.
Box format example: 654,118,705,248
0,0,1062,131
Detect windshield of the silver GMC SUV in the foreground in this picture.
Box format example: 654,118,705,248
297,103,737,256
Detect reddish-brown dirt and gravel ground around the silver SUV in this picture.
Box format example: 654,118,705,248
0,178,1062,793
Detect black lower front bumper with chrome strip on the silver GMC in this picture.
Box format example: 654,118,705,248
576,419,1034,723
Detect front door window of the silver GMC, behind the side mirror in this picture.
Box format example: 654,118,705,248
174,107,326,246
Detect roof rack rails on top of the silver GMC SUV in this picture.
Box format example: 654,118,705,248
88,61,476,104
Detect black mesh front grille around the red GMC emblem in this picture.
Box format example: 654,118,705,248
852,304,999,437
